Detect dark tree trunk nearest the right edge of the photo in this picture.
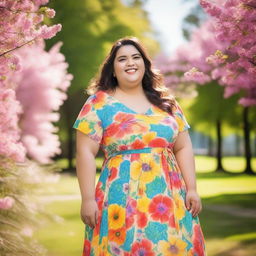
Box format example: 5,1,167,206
243,107,255,174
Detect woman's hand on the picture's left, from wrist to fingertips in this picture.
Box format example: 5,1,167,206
81,199,99,228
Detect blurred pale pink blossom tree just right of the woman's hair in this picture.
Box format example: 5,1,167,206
155,21,224,96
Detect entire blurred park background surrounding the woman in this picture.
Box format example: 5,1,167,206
0,0,256,256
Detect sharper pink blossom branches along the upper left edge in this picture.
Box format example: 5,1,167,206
0,0,61,161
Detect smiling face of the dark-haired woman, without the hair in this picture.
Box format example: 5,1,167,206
114,45,145,87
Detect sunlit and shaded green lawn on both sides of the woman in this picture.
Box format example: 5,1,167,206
36,157,256,256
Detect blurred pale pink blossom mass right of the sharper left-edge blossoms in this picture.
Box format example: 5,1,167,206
13,42,72,163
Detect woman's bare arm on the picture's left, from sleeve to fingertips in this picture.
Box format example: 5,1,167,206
76,130,99,228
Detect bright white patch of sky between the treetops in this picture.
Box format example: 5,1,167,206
144,0,195,55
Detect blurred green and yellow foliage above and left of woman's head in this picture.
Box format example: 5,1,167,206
48,0,157,95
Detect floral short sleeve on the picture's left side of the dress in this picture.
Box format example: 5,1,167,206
73,95,103,144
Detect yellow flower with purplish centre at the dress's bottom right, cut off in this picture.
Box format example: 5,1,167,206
159,237,187,256
